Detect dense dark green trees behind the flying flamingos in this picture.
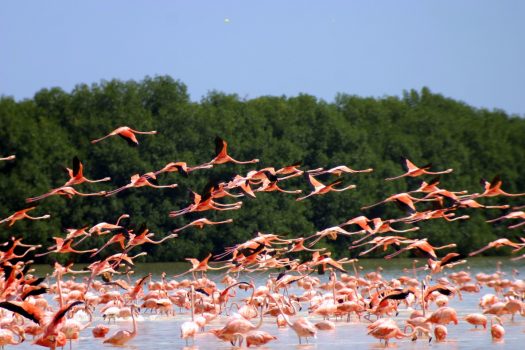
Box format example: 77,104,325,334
0,77,525,261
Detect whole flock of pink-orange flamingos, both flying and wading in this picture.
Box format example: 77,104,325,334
0,127,525,349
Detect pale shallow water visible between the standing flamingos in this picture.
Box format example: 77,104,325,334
17,257,525,350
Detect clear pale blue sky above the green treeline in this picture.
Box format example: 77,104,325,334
0,0,525,116
